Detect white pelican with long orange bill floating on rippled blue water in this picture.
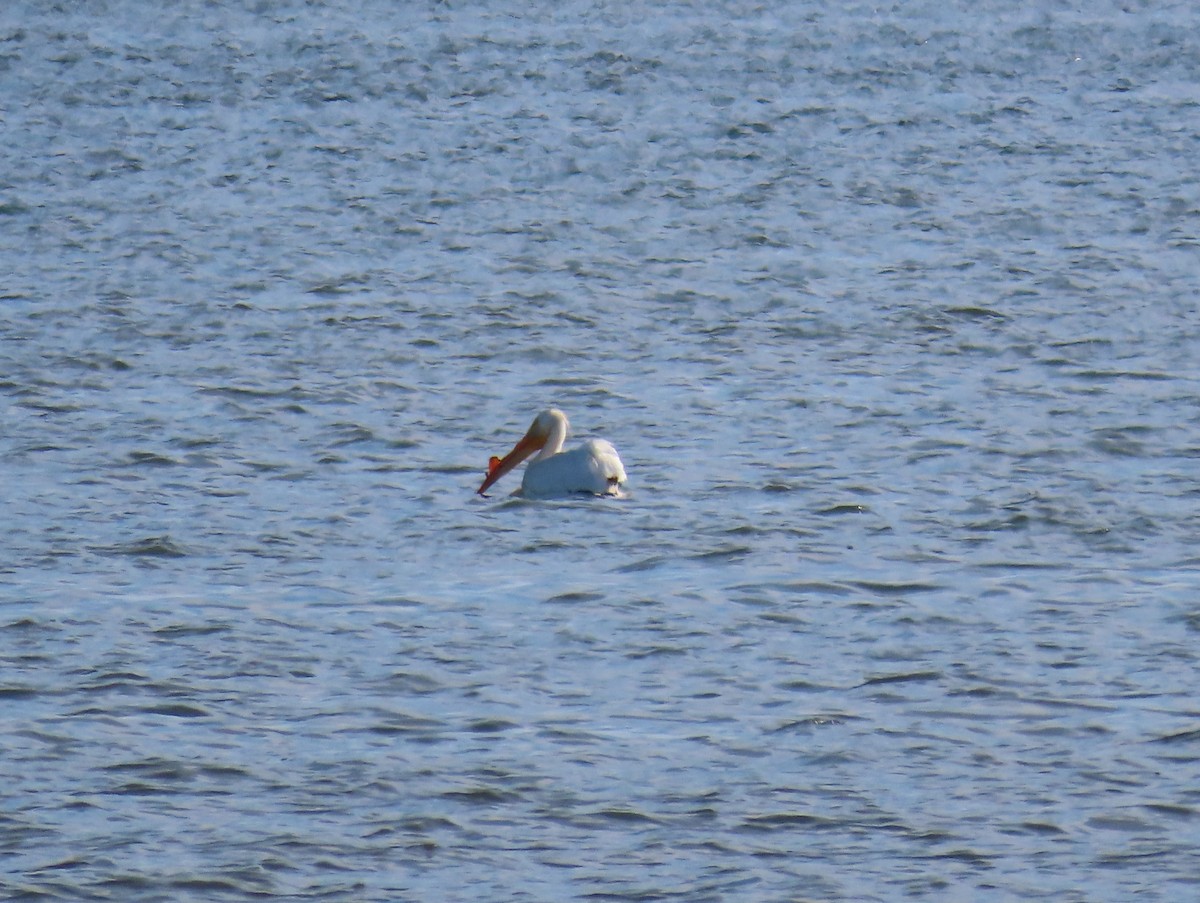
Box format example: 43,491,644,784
479,407,625,498
